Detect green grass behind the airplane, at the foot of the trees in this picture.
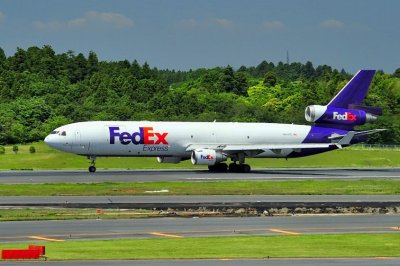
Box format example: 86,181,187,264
0,142,400,170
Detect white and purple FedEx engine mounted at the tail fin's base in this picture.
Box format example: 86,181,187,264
305,105,377,126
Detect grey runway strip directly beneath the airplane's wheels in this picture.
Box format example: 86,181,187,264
0,168,400,184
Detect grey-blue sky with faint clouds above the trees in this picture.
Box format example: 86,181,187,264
0,0,400,73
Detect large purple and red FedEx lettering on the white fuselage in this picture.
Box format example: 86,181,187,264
108,127,168,145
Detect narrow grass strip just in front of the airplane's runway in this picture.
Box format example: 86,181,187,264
0,179,400,196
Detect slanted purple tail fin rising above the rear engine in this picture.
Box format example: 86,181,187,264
327,70,375,108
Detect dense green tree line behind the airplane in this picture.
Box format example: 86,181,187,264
0,45,400,144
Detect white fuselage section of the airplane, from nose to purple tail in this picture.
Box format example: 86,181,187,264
45,121,311,159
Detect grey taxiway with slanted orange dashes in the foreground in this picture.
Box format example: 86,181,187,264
0,215,400,243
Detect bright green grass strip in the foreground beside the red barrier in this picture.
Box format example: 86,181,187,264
0,233,400,260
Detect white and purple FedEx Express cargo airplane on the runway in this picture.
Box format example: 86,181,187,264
44,70,385,173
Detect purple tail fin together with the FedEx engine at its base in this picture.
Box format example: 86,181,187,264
305,70,382,130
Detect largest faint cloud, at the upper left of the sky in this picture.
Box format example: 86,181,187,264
32,11,134,30
